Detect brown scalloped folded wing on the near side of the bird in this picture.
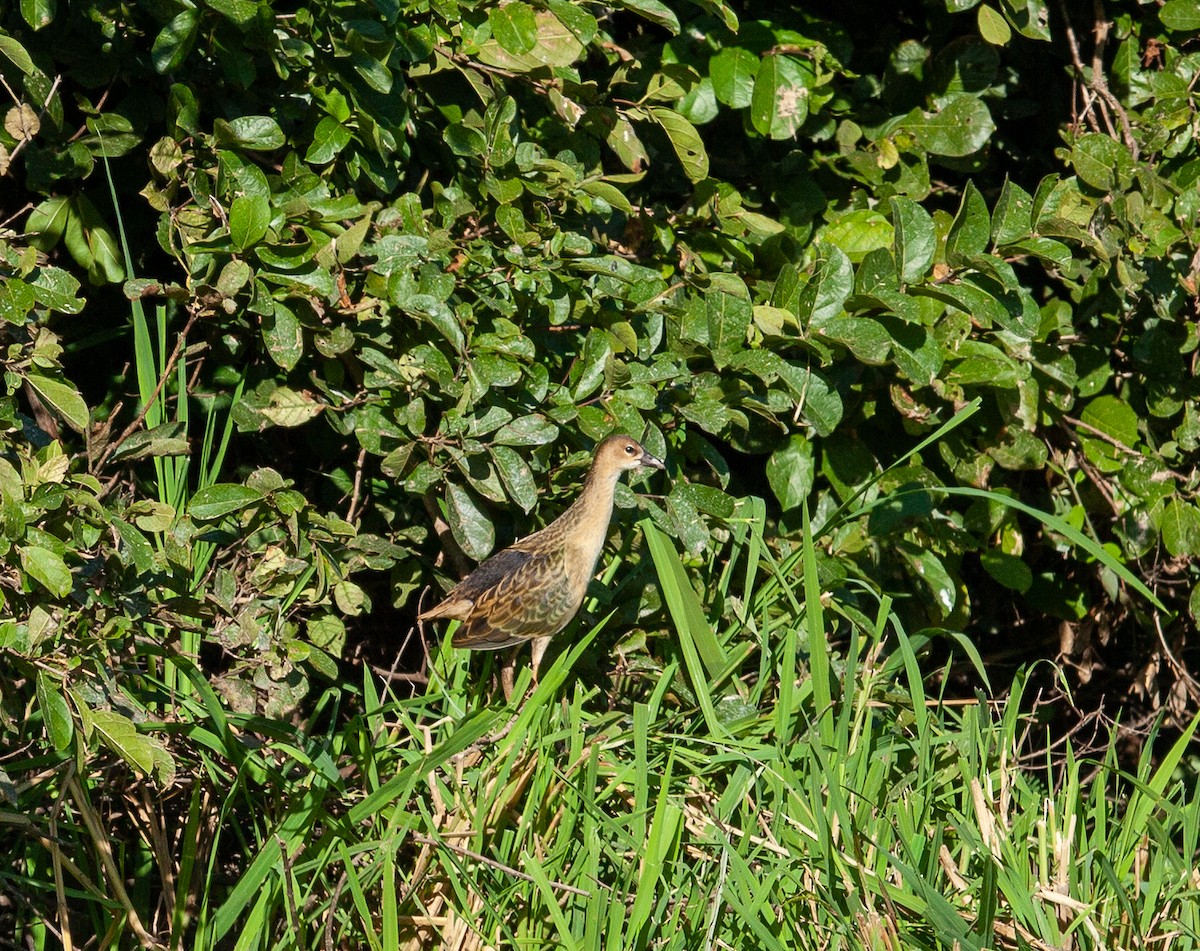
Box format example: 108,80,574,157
454,549,578,650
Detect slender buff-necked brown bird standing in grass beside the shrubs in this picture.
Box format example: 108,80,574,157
418,435,666,696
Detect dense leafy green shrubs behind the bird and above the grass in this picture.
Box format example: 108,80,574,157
0,0,1200,946
